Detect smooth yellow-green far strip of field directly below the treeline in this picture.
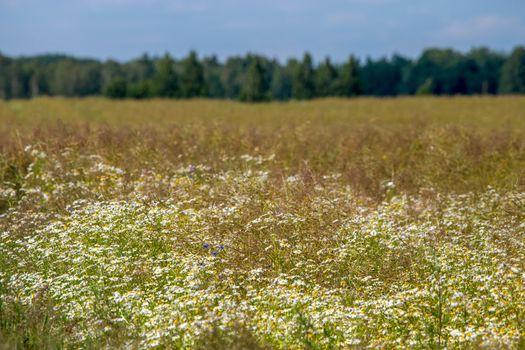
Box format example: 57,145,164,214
0,96,525,130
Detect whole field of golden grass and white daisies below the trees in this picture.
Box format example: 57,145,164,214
0,96,525,349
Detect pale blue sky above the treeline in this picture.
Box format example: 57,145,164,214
0,0,525,61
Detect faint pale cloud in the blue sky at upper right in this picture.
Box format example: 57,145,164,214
445,15,519,39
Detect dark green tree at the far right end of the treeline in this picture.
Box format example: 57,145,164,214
500,46,525,94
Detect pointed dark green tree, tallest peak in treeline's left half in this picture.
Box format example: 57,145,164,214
181,51,208,98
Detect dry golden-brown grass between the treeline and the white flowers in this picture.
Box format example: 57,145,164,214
0,97,525,197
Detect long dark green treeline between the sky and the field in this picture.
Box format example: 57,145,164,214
0,47,525,102
